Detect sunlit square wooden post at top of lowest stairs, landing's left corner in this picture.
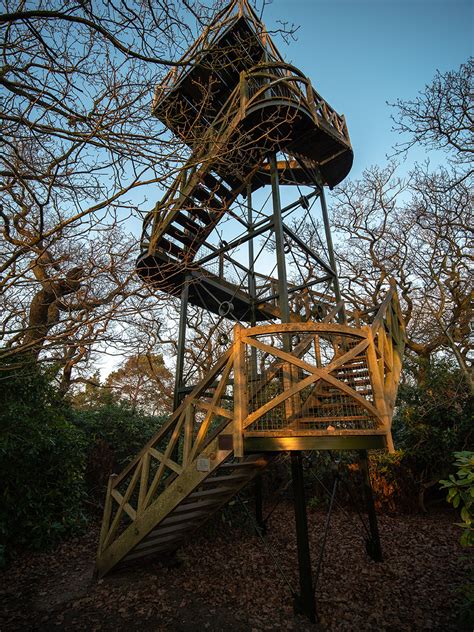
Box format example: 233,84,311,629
233,324,248,458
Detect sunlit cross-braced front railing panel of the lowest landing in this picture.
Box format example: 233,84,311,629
240,323,383,434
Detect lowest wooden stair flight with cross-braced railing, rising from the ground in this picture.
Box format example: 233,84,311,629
97,350,271,576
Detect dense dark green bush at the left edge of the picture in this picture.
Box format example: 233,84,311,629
0,359,85,552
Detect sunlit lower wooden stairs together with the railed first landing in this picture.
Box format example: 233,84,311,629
97,288,404,575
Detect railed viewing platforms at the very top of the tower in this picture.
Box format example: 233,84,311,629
153,0,353,189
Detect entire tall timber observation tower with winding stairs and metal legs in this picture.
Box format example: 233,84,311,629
97,0,404,620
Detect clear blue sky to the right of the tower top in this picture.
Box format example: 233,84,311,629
259,0,474,178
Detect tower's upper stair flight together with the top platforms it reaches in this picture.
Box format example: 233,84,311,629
137,10,353,304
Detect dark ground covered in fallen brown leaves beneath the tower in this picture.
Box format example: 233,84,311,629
0,503,468,632
